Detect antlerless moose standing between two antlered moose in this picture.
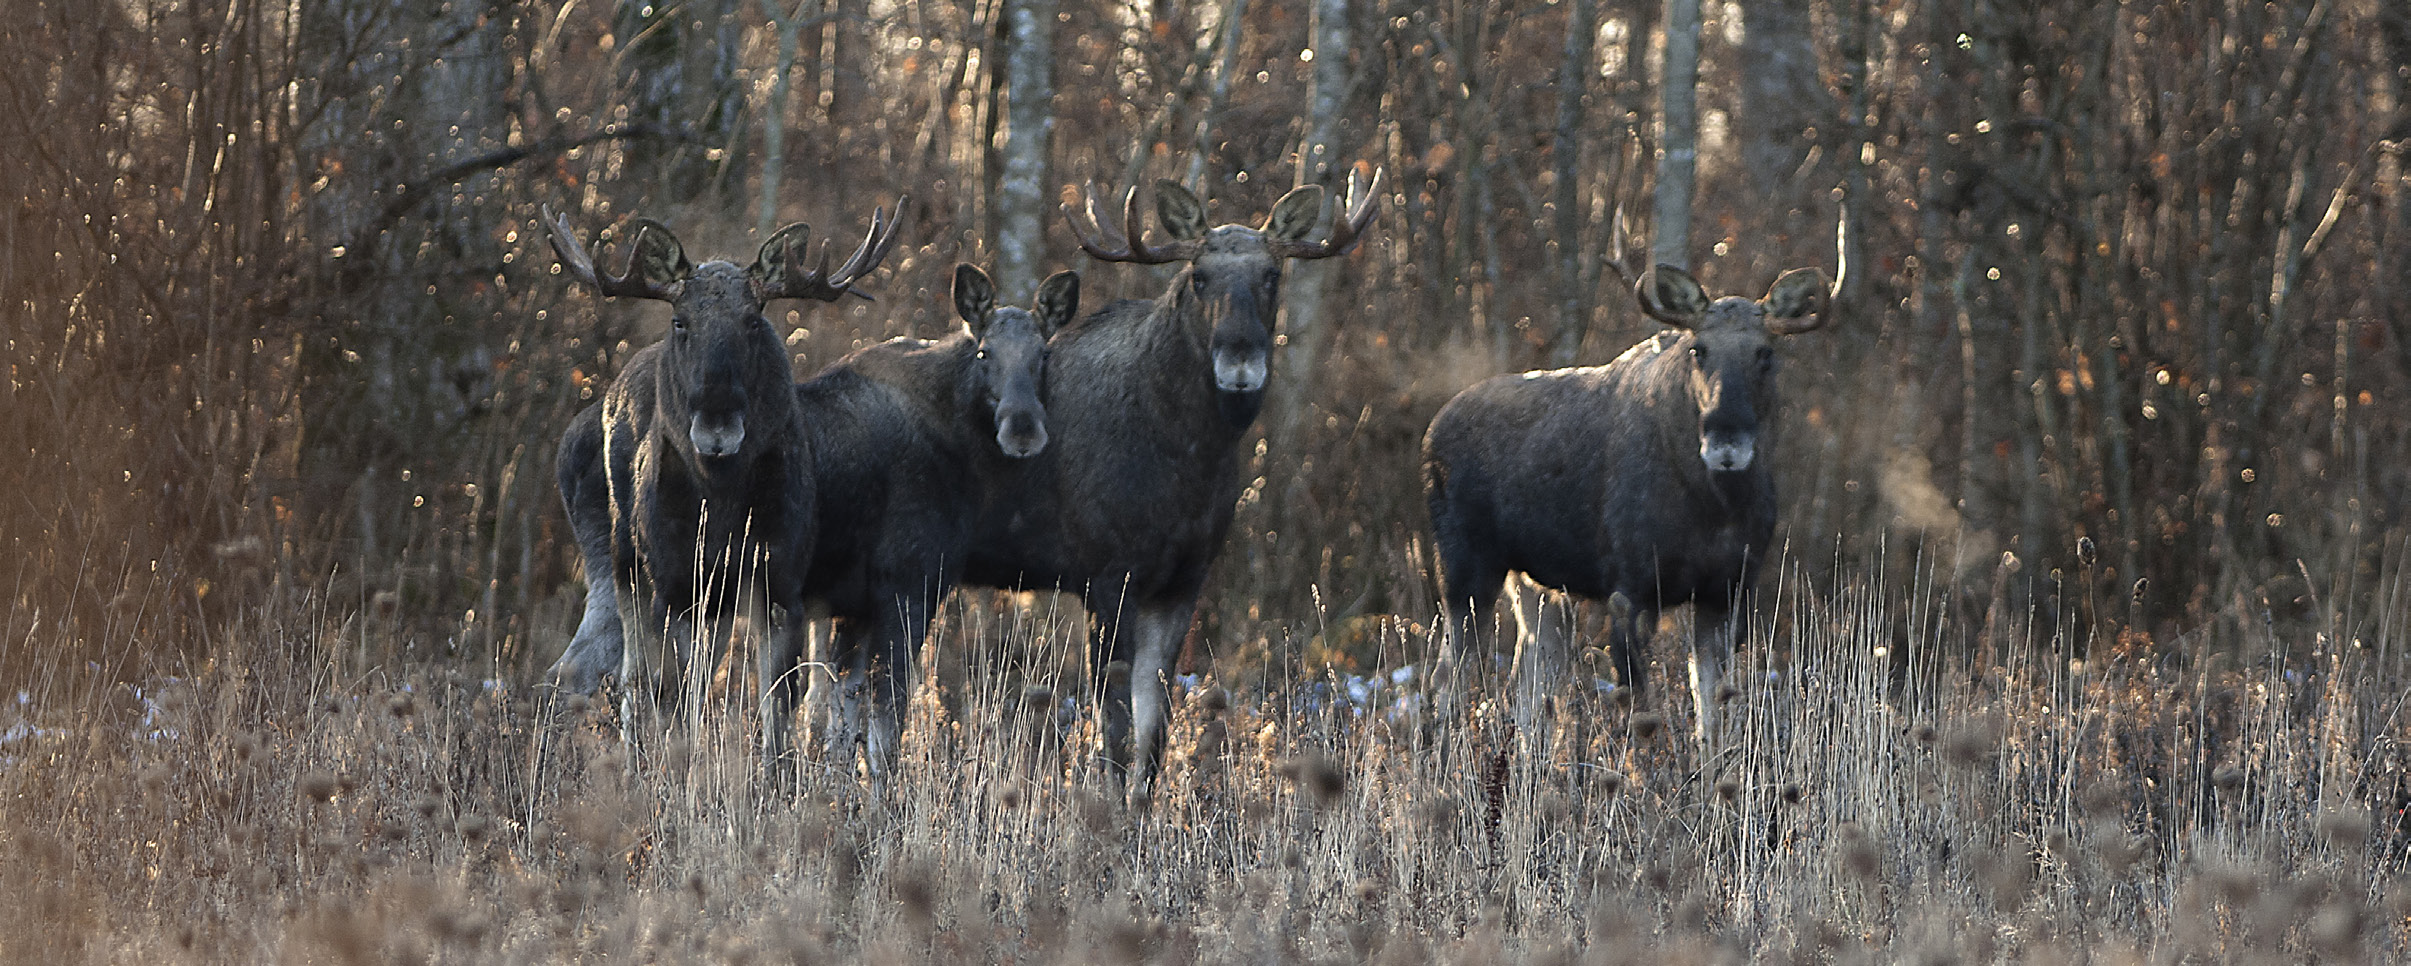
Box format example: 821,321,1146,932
764,265,1080,778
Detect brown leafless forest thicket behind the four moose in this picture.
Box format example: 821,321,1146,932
0,0,2411,687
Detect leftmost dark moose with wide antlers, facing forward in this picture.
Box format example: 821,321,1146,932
547,210,897,766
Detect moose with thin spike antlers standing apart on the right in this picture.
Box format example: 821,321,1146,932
1422,265,1828,740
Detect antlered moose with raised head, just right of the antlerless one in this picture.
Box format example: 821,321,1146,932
964,171,1382,805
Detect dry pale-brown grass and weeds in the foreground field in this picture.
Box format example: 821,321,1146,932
0,549,2411,964
